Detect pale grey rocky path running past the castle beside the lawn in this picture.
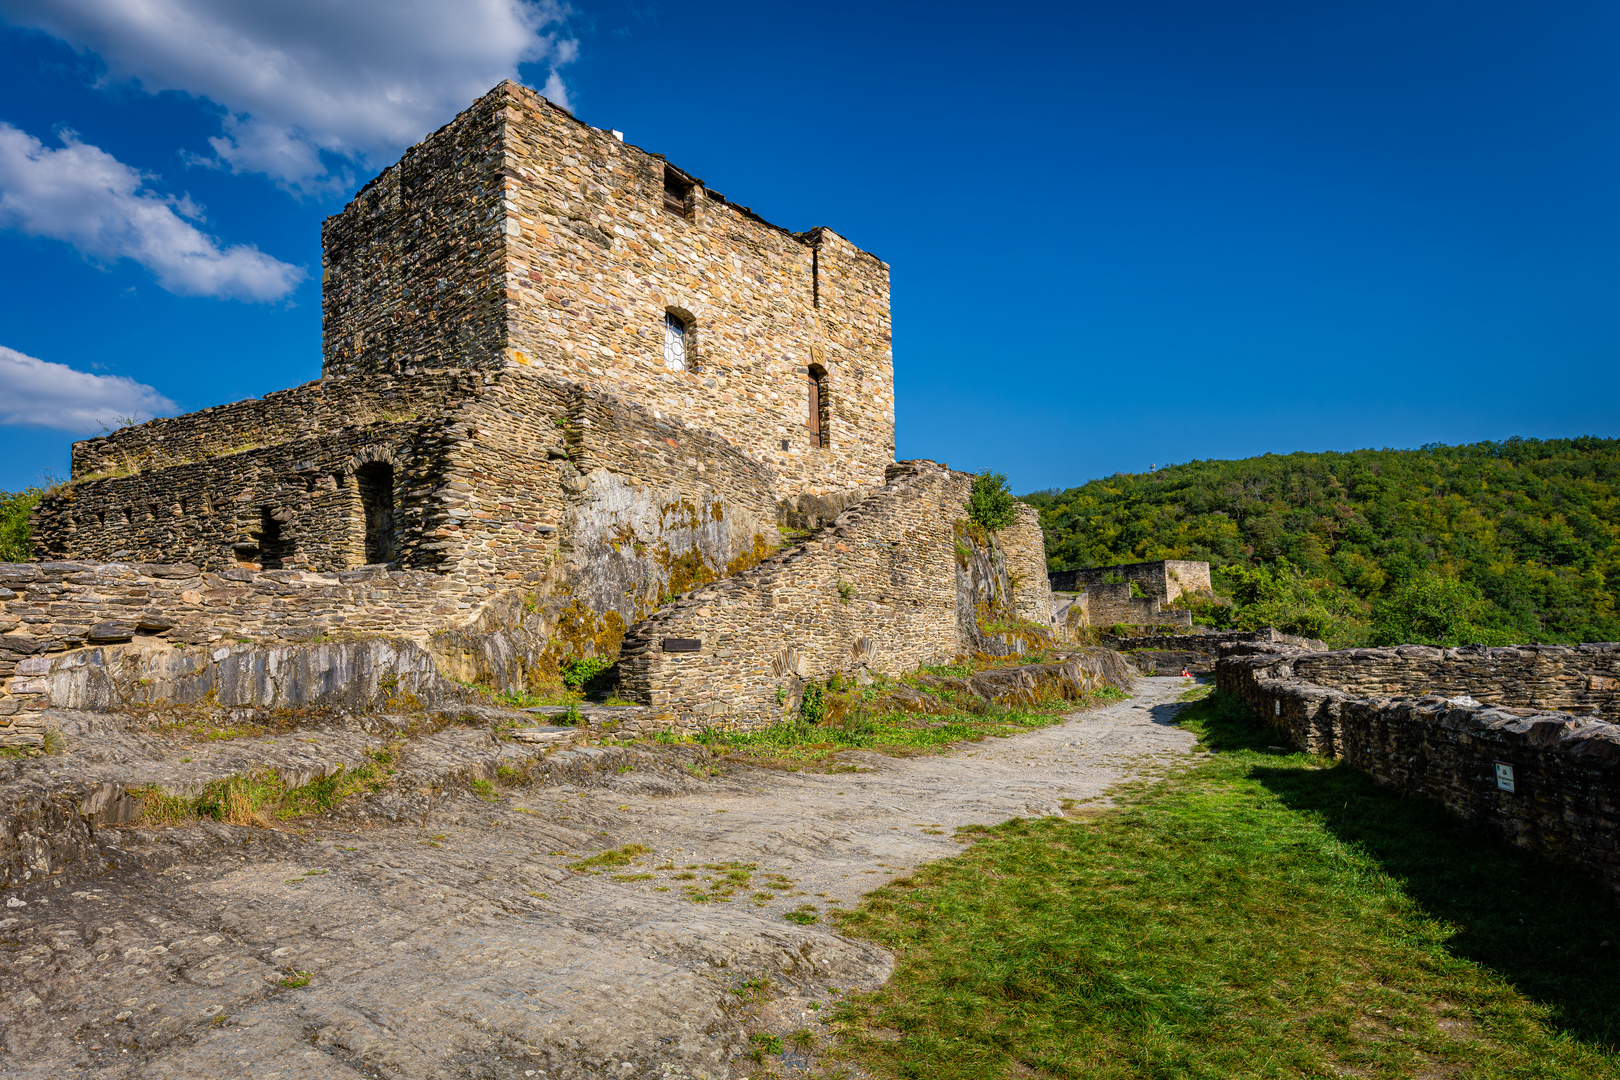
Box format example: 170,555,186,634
0,678,1192,1080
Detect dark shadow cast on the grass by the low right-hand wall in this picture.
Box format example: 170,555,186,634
1204,704,1620,1049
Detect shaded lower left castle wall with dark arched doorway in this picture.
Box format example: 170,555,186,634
34,371,483,570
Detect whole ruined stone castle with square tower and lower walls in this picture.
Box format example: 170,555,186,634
0,83,1051,722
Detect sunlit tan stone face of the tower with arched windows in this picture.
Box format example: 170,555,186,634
497,84,894,494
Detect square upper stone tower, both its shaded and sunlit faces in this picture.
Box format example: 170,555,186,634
324,83,894,495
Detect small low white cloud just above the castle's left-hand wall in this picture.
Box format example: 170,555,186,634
0,345,175,432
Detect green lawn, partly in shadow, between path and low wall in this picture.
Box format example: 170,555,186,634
834,695,1620,1080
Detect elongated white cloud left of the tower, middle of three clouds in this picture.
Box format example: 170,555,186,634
0,123,305,300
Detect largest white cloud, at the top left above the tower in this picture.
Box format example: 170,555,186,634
0,0,578,191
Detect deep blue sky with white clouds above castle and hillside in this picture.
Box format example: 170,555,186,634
0,0,1620,492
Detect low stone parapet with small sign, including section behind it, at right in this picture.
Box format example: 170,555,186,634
1217,644,1620,892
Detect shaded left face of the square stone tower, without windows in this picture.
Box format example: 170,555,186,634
321,94,507,377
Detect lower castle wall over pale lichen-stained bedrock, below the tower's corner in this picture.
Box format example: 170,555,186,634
436,369,779,656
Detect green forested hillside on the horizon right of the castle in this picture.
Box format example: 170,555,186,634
1024,437,1620,644
